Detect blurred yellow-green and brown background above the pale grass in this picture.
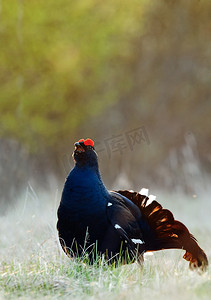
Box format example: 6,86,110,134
0,0,211,211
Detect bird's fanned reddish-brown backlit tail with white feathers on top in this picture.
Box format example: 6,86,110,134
117,190,208,269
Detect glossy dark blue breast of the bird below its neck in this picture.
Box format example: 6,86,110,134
59,173,108,239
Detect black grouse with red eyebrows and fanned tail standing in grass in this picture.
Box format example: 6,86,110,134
57,138,208,270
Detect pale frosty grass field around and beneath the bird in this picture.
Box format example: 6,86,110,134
0,191,211,300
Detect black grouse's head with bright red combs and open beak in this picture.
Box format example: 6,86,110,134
73,138,98,167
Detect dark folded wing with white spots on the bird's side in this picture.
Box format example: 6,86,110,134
107,192,145,254
